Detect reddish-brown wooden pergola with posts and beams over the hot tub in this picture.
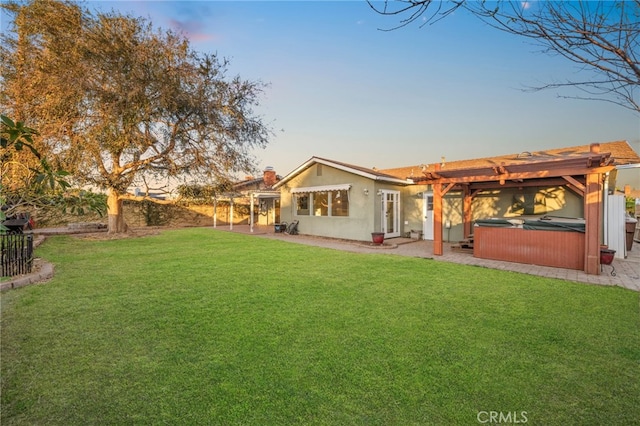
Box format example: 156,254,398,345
414,144,615,275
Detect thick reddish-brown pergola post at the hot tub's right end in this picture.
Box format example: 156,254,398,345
584,173,602,275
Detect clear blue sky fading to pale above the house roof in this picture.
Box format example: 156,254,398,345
32,1,640,175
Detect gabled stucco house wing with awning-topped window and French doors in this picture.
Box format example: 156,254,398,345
274,157,419,240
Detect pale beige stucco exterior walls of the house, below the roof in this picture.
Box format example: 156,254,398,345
280,177,584,242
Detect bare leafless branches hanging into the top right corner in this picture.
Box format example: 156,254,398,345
368,0,640,112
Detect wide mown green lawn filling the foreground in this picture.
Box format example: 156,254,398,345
0,229,640,426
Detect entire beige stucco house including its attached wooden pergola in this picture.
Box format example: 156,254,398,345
274,141,640,273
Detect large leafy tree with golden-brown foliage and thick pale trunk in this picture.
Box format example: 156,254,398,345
0,0,271,232
